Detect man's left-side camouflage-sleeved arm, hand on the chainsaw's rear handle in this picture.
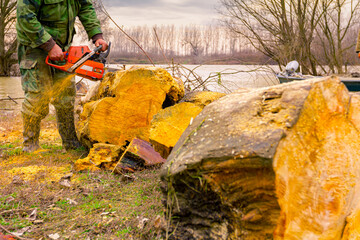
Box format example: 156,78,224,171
16,0,63,60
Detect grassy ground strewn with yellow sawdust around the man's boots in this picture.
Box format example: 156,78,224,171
0,111,164,239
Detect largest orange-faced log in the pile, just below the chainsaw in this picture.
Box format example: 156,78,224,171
77,67,184,148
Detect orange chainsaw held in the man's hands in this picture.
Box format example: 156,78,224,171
46,43,111,81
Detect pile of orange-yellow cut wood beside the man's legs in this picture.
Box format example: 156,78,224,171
75,67,229,171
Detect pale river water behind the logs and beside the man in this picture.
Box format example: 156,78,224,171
0,65,278,111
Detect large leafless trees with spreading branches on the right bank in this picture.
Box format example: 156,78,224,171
220,0,359,75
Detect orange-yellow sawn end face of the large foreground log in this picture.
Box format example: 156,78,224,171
273,81,360,240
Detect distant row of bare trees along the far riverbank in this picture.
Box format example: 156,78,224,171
99,25,270,64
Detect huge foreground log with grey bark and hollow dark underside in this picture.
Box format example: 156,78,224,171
161,78,360,240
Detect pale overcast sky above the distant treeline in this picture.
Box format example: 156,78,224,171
103,0,219,26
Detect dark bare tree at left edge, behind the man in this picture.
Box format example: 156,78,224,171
0,0,17,76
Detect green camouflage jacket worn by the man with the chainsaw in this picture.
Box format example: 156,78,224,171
16,0,101,48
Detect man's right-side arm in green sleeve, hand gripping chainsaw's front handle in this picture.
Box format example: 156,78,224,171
78,0,107,51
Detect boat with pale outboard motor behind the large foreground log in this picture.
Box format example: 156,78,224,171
276,61,360,92
